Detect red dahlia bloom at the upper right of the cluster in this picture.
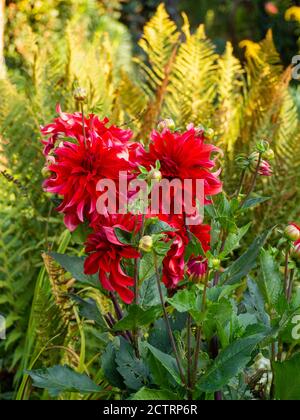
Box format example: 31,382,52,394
143,126,222,203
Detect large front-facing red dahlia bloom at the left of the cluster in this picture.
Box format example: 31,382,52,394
44,139,132,231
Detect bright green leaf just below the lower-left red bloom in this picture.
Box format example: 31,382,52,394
114,305,162,331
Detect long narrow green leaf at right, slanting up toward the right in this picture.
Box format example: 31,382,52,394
221,229,273,284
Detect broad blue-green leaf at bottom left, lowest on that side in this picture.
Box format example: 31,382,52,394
26,366,102,397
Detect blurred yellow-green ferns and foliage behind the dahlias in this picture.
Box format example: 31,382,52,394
0,0,300,397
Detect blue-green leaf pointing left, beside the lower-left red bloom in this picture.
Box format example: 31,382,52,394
49,252,100,289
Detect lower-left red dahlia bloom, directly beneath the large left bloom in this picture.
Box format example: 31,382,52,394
84,215,140,304
